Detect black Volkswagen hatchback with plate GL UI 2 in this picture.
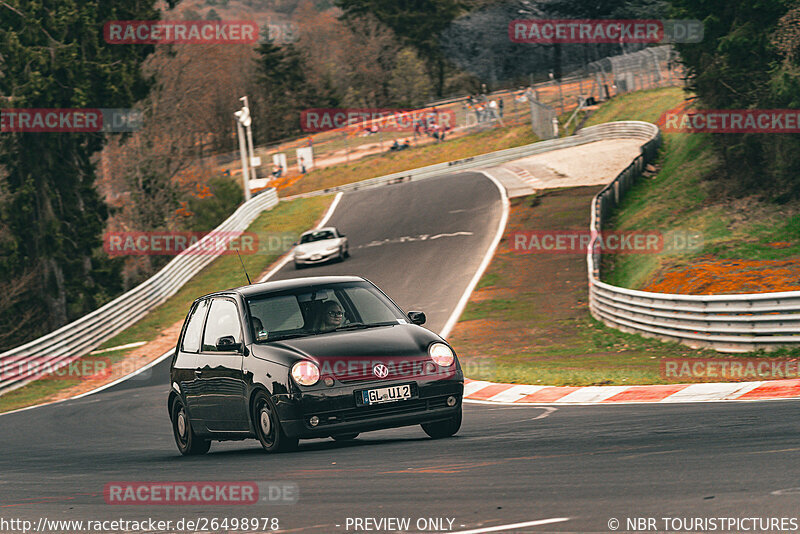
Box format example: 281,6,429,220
168,276,464,454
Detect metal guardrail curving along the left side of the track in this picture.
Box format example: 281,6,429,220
0,189,278,393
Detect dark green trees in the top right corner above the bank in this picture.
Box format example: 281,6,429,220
673,0,800,202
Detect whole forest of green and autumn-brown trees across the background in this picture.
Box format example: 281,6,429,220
0,0,800,350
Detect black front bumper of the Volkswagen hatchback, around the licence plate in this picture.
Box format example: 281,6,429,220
273,371,464,439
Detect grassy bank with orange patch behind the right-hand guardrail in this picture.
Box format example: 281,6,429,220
604,95,800,294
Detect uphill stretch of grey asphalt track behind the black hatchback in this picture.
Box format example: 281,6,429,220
271,173,502,332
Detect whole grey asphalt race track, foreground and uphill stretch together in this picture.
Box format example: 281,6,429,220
0,174,800,533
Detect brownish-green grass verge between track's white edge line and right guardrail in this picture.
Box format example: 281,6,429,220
449,187,718,386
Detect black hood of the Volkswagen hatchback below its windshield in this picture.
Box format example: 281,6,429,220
248,324,457,382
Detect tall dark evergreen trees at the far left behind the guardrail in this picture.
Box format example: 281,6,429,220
0,0,164,347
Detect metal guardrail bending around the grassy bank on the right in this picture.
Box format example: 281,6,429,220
586,123,800,352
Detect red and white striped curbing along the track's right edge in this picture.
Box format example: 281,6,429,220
464,379,800,405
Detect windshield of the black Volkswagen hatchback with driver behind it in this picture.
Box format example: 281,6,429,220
247,282,405,343
